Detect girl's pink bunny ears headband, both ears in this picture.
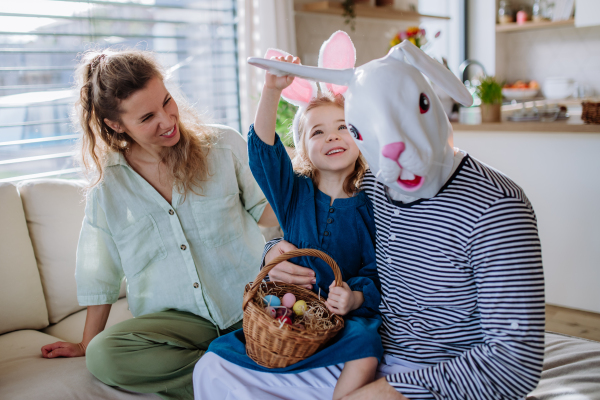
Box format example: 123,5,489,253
265,31,356,146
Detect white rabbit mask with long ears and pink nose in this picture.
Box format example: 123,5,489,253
248,40,473,198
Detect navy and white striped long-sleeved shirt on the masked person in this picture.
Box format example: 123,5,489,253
363,155,544,400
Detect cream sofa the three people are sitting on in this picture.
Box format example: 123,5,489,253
0,179,600,400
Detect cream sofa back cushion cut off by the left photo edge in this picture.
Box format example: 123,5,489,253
0,183,48,334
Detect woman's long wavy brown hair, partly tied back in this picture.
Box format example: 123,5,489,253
74,50,216,195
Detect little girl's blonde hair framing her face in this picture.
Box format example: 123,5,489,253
290,92,367,196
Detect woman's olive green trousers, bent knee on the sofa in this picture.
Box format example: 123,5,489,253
86,311,242,399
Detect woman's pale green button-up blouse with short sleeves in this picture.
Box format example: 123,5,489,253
75,125,267,329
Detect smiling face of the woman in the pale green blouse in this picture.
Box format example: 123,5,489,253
105,77,180,153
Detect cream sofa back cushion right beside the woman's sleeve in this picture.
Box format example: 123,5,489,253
18,179,90,323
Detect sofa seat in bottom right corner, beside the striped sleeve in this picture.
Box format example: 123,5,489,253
528,332,600,400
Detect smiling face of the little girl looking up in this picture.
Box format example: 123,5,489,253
304,105,360,174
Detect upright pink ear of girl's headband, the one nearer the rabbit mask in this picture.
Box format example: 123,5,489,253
319,31,356,94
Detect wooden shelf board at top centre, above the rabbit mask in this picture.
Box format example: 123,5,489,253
300,1,450,21
